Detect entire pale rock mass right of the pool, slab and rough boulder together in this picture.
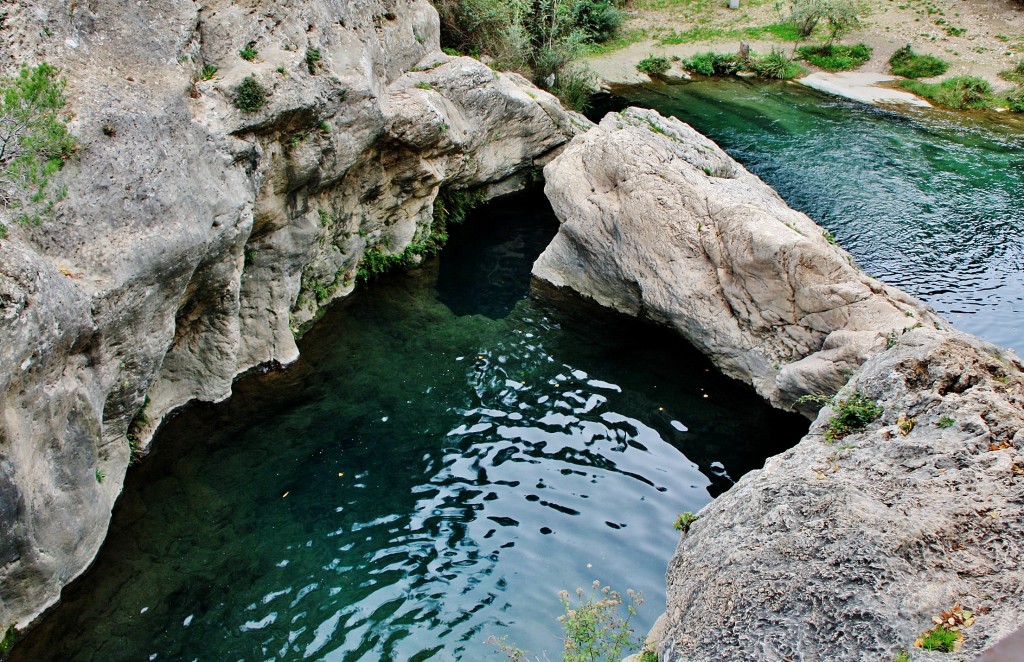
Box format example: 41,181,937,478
534,109,1024,660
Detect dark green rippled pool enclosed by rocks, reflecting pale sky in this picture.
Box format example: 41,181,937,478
11,189,807,662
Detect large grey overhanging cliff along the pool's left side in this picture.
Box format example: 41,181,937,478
0,0,589,634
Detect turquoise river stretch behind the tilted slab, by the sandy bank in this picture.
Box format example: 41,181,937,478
601,80,1024,356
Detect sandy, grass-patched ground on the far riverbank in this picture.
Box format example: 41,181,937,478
587,0,1024,89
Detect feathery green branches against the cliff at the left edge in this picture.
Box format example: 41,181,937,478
0,63,78,236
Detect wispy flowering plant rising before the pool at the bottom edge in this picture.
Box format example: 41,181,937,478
558,581,643,662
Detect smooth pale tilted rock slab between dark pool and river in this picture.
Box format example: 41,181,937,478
534,109,945,407
